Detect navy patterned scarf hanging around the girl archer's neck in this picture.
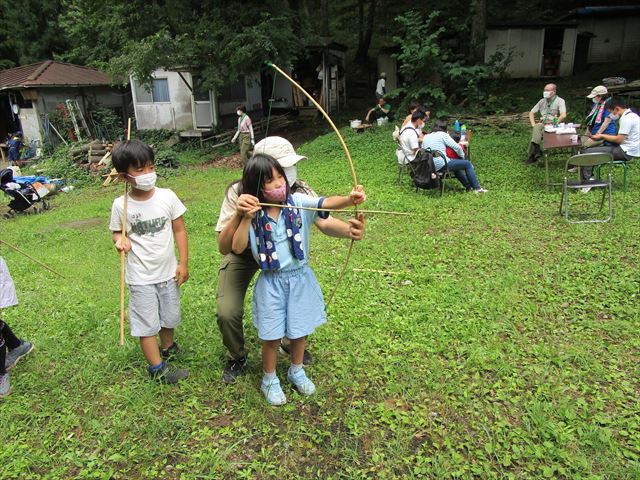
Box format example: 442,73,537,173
251,195,304,270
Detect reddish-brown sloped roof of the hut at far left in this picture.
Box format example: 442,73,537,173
0,60,111,90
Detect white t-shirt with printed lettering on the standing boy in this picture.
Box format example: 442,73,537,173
109,187,187,285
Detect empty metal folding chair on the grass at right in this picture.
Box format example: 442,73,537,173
560,153,613,223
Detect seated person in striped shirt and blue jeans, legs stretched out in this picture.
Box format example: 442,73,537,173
422,120,487,193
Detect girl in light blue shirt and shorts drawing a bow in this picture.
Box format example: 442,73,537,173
232,155,366,405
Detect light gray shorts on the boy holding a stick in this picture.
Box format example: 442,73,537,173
129,278,180,337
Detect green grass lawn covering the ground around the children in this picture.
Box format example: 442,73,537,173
0,124,640,479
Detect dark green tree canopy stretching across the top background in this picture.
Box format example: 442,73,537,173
0,0,636,106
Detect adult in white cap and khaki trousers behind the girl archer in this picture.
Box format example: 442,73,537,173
216,137,365,383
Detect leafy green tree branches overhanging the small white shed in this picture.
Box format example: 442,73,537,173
62,0,304,87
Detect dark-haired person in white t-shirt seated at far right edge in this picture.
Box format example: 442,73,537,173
582,97,640,183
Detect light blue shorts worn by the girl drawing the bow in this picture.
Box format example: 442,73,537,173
253,265,327,340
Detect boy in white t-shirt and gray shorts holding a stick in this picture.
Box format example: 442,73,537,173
109,140,189,383
